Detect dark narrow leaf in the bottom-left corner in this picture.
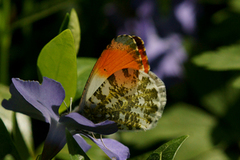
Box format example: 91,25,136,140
0,118,21,160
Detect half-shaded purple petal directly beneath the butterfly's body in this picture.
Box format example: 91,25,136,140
59,112,118,135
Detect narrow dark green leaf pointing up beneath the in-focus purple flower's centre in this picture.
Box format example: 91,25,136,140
66,129,90,160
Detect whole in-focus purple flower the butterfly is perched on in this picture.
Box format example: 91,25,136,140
2,77,129,160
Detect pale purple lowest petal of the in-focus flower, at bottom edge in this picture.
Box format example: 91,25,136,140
89,137,130,160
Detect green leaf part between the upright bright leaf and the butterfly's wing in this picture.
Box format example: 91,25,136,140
75,57,97,99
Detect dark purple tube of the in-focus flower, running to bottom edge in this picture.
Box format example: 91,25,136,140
42,119,66,159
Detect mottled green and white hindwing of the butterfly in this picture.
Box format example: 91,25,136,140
81,68,166,130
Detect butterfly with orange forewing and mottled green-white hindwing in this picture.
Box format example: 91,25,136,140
77,35,166,130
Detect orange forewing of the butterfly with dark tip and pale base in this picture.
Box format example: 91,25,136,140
80,35,146,110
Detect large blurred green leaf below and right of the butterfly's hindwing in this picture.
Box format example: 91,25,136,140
119,103,224,159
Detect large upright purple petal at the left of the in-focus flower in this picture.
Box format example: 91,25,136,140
2,77,65,123
